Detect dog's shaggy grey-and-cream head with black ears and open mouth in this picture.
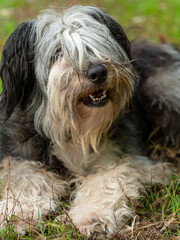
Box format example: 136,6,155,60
0,6,134,154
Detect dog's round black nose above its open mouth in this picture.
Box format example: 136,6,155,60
88,64,107,83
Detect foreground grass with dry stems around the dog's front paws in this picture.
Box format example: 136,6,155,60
0,177,180,240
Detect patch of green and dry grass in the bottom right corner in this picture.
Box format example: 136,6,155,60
135,177,180,239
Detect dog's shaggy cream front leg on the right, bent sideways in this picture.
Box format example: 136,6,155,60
69,161,169,239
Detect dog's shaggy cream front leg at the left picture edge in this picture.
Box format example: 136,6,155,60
0,157,67,233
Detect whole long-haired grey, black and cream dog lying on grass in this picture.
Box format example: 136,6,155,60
0,6,180,238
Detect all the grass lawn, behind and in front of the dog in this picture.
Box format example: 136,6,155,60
0,0,180,240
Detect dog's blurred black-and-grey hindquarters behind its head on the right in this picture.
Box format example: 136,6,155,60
131,41,180,145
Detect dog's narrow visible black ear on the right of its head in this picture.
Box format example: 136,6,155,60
90,9,131,58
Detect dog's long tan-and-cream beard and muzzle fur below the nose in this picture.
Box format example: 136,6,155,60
36,59,133,155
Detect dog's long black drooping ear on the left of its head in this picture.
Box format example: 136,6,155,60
0,21,35,119
